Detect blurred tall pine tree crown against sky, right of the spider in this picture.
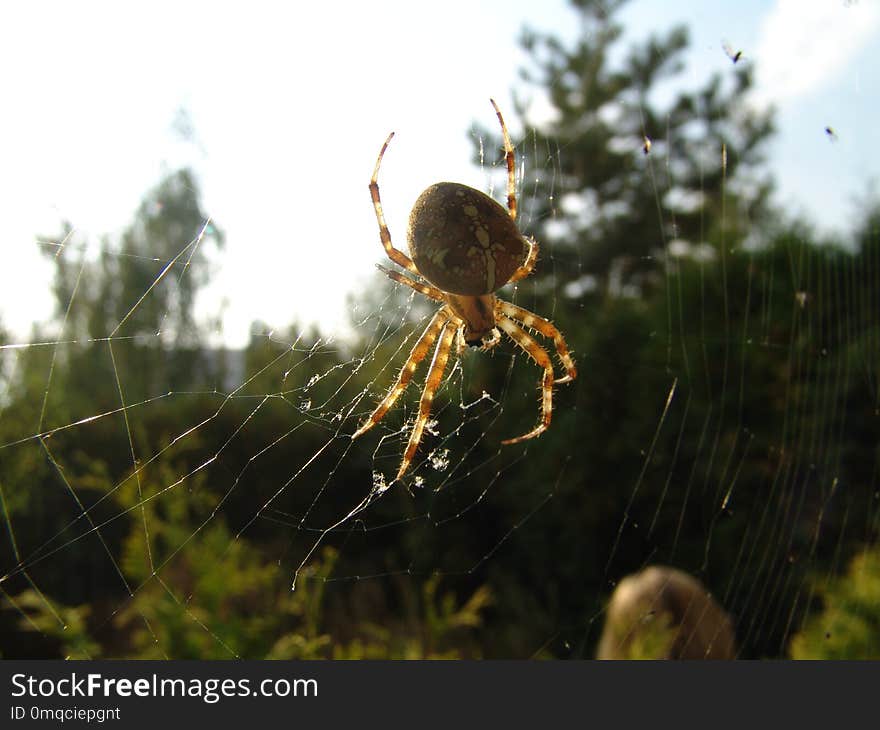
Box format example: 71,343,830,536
479,0,773,295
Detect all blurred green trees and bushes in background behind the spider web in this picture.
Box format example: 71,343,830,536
0,0,880,659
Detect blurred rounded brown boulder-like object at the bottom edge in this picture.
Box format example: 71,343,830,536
596,565,736,659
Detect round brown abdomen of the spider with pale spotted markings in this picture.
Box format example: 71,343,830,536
407,182,529,296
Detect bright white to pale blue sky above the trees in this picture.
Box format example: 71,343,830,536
0,0,880,346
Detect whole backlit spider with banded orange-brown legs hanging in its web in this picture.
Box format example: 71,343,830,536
352,99,577,481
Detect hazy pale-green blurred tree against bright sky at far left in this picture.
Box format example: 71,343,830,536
41,169,224,410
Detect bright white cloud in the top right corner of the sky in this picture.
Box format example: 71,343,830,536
753,0,880,105
